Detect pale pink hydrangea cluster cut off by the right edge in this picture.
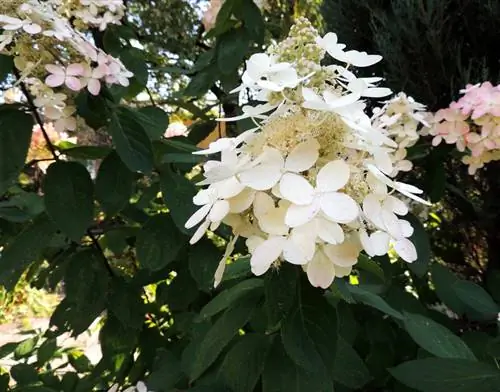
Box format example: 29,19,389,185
427,82,500,174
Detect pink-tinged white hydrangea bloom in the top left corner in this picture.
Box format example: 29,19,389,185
0,0,133,132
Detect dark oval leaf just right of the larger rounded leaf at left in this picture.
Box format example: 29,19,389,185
95,151,134,216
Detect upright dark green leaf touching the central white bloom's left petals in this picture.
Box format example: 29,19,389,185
160,165,197,234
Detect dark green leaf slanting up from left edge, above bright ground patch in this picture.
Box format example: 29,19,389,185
0,214,56,290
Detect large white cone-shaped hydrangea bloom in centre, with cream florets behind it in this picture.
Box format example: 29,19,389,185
186,19,427,288
